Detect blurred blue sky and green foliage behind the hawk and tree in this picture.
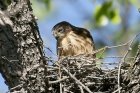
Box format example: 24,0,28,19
0,0,140,93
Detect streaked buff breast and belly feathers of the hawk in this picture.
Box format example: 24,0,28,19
59,33,94,56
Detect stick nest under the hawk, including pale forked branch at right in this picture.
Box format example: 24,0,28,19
47,35,138,93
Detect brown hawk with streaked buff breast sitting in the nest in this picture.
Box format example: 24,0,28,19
52,21,96,65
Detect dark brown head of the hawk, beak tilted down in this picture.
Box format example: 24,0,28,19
52,21,72,40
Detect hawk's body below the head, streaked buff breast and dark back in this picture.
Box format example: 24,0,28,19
57,27,95,58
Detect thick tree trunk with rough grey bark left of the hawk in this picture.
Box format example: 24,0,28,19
0,0,48,93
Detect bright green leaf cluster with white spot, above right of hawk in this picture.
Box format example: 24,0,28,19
94,1,121,26
